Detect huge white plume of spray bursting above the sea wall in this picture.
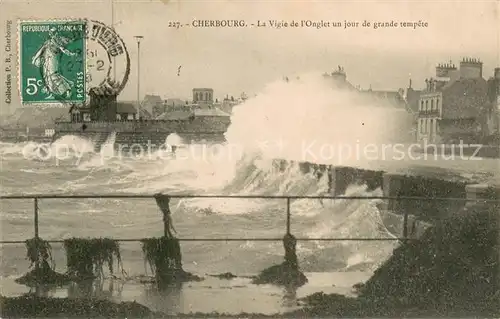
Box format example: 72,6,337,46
226,74,411,164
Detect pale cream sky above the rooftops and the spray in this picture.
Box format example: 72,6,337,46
0,0,500,115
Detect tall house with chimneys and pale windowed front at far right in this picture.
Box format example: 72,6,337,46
417,58,488,144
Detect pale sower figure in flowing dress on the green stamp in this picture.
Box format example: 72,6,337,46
31,28,76,99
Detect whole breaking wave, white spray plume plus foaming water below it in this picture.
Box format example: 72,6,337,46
0,74,412,271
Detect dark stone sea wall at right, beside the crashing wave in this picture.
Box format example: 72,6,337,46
273,159,500,229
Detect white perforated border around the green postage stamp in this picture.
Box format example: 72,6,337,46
16,17,88,108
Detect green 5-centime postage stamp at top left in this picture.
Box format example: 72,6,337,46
19,20,86,104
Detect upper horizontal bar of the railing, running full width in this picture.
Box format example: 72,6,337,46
0,194,500,203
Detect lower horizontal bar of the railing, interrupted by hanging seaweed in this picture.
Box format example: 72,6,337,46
0,237,411,245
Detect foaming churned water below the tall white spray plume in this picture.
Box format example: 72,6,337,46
1,142,394,271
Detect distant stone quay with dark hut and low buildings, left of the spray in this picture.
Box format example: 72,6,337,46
56,90,231,150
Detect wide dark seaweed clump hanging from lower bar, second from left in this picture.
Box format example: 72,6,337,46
64,238,125,280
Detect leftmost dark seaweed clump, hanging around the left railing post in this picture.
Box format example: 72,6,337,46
16,237,70,287
